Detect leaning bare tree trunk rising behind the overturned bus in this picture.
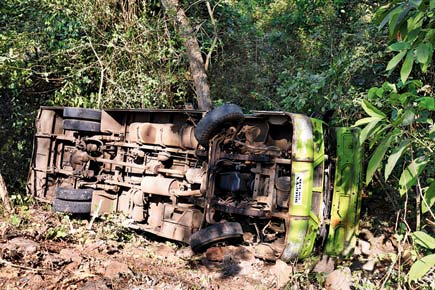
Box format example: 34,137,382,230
162,0,211,111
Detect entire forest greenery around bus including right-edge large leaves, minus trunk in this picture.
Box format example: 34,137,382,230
0,0,435,286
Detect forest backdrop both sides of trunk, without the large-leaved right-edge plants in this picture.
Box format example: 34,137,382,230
0,0,386,187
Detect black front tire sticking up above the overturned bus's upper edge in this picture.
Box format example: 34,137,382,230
195,104,245,148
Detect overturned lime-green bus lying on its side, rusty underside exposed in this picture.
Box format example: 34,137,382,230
28,104,362,261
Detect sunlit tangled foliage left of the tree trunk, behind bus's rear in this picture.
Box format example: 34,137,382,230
0,0,193,192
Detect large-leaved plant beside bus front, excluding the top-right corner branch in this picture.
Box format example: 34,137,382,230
356,81,435,282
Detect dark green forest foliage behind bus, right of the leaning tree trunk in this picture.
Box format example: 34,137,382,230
210,0,383,124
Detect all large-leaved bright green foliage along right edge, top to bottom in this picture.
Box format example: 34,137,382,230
355,0,435,283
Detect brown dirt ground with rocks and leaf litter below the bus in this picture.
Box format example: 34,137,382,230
0,196,433,290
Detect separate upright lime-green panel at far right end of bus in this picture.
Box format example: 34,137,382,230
325,127,363,256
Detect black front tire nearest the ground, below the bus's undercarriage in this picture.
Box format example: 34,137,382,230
190,222,243,252
